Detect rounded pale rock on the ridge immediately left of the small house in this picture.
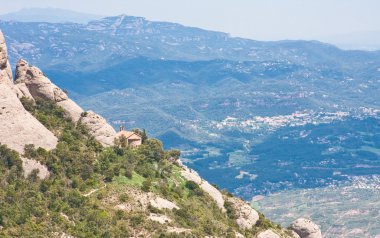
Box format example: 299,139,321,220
80,111,116,146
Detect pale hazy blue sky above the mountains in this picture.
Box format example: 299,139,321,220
0,0,380,49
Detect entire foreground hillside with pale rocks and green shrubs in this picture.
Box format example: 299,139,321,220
0,32,326,238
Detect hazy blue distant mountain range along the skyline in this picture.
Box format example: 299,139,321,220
0,15,380,71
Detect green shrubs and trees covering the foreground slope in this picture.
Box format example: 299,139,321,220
0,99,284,237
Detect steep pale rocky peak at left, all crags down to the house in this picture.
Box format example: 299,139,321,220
0,31,116,178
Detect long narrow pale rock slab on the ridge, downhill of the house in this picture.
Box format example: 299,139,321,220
181,166,226,212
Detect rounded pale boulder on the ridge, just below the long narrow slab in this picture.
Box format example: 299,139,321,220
226,197,259,229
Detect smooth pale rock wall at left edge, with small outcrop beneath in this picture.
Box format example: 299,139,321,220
0,32,58,179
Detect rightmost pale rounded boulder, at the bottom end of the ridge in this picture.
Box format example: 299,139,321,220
289,218,322,238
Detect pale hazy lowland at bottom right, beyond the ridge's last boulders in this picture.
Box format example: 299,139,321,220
254,175,380,238
